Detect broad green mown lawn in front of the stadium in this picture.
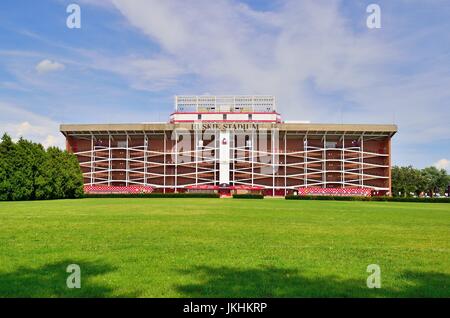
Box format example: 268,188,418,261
0,199,450,297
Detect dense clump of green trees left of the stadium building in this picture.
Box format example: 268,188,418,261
0,134,83,200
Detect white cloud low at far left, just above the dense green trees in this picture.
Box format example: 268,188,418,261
0,102,65,149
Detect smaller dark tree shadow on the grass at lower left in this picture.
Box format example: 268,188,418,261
0,260,135,297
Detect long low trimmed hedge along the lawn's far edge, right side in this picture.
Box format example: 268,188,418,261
285,195,450,203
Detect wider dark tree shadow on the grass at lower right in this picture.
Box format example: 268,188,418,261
176,266,450,298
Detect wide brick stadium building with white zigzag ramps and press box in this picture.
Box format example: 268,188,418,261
61,96,397,195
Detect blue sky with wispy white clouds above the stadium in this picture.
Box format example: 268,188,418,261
0,0,450,169
